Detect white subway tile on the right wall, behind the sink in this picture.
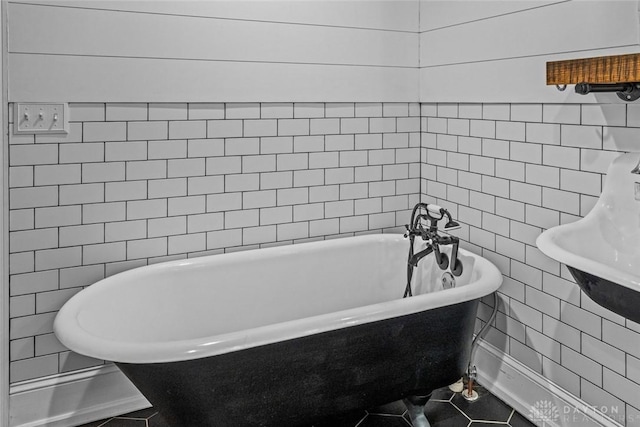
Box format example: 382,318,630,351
420,104,640,425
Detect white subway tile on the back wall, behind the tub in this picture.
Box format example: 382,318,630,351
9,103,420,383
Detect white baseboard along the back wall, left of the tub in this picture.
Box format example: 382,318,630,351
9,365,151,427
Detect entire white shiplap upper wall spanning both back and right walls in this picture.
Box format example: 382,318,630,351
7,0,640,103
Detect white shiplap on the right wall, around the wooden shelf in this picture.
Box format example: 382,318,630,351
420,0,640,103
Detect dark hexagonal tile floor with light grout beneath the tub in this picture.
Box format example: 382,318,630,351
80,386,534,427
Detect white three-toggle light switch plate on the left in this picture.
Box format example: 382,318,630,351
13,102,69,134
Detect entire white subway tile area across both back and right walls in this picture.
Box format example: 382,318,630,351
9,99,640,421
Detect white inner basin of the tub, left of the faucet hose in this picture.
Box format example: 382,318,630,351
78,236,408,343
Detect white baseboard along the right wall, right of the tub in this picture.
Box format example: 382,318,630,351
473,340,622,427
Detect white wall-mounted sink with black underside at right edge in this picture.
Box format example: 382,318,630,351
536,153,640,323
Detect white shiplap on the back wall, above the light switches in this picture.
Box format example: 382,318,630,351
8,0,419,102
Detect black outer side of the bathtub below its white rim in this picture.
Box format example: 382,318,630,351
117,300,478,427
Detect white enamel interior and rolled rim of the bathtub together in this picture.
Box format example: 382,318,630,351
54,235,500,361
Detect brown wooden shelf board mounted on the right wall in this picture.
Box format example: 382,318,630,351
547,53,640,85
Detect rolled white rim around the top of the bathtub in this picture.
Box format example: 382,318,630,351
53,234,502,363
